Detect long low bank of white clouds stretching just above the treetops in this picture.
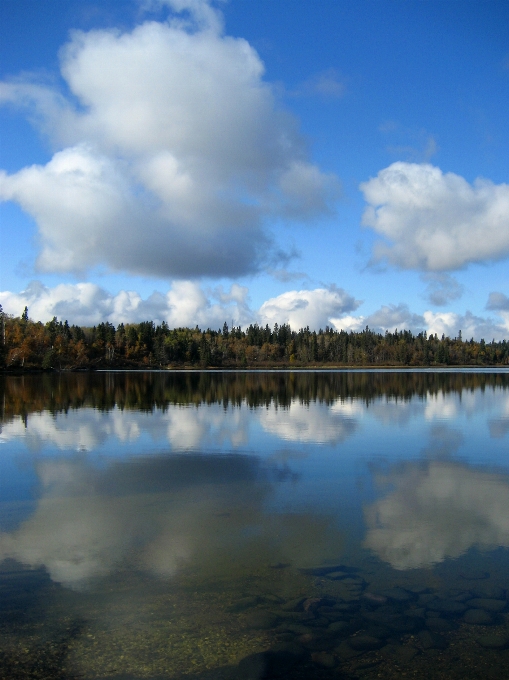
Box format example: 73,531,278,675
0,281,509,341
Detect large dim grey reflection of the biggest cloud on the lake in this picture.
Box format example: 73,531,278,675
0,453,341,589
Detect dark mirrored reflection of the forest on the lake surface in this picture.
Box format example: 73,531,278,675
0,371,509,423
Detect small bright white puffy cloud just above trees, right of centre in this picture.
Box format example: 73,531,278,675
258,287,360,330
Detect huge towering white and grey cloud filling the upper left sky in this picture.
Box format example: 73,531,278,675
0,0,338,278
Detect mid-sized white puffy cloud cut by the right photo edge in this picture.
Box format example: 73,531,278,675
360,162,509,271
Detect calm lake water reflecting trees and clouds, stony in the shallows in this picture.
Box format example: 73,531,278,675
0,371,509,680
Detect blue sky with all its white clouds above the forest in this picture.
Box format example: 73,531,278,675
0,0,509,341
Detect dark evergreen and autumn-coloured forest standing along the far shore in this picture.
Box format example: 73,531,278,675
0,308,509,370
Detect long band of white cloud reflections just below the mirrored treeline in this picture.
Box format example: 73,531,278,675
0,382,509,451
